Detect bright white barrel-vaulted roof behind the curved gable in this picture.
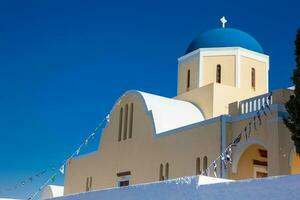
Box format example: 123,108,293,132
125,90,204,134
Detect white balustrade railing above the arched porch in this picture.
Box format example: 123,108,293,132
239,93,273,114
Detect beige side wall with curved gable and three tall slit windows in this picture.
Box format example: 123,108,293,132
65,94,220,194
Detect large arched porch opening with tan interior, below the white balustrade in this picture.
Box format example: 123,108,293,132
231,144,268,180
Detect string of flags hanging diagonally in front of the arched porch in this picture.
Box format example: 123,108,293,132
201,92,272,178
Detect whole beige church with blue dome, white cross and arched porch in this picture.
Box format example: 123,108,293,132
64,18,300,195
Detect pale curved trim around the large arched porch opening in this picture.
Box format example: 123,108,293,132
231,138,267,173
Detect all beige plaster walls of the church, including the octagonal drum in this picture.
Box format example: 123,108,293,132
65,45,298,194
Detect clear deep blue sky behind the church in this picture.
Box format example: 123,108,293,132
0,0,300,197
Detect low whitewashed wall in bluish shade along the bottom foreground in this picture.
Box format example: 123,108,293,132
55,175,300,200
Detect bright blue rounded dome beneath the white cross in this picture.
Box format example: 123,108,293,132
185,28,264,54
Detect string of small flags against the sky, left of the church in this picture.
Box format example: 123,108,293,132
23,115,109,200
